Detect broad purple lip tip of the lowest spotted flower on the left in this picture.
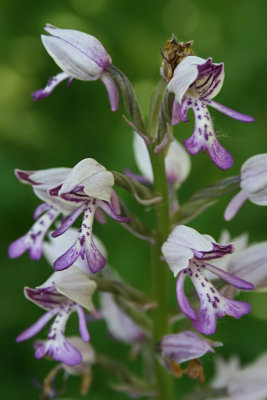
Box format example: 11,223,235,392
35,339,82,366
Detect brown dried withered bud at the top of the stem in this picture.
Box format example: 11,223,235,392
161,35,194,81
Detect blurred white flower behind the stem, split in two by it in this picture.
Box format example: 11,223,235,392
134,133,191,189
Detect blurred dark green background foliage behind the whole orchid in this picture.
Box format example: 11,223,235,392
0,0,267,400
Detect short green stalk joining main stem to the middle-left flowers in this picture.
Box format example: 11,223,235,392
112,171,161,205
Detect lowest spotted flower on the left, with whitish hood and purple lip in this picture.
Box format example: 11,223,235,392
17,267,96,366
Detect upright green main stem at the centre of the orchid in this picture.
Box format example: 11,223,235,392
150,148,174,400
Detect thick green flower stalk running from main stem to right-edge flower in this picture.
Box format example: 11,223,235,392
171,176,240,225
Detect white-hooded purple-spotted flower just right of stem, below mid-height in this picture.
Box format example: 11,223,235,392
162,225,254,335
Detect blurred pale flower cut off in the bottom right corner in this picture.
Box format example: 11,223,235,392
208,353,267,400
